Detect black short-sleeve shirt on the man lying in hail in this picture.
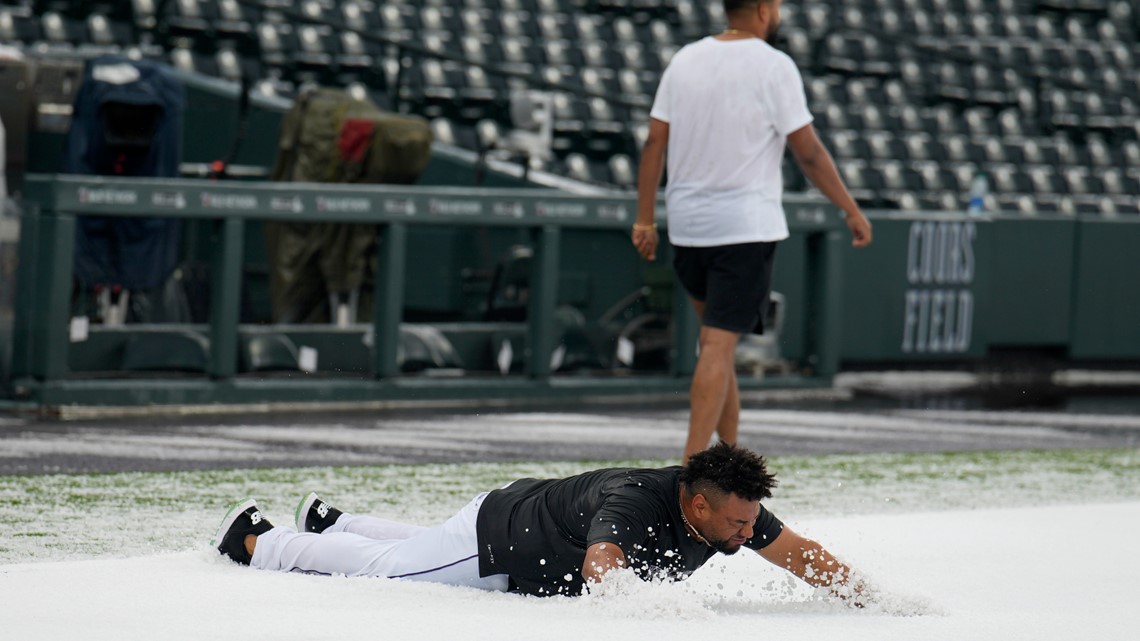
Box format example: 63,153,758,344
475,466,783,595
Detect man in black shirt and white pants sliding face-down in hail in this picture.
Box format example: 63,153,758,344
213,443,869,606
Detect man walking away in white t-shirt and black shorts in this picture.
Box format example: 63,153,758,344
632,0,871,460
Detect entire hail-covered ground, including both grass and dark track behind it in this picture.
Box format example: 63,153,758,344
0,403,1140,641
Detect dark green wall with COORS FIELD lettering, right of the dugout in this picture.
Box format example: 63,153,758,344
840,213,1140,367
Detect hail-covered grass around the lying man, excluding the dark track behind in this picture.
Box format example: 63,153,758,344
0,449,1140,641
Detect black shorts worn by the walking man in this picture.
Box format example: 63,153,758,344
673,243,776,334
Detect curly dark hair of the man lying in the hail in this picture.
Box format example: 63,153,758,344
681,440,776,501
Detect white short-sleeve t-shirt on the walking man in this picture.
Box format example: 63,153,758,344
650,36,813,246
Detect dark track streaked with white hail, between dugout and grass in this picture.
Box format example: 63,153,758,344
0,393,1140,474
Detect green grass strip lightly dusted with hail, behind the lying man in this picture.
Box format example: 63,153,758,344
0,449,1140,563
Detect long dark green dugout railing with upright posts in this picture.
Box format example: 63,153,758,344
9,176,846,408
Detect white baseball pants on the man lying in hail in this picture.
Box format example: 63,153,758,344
251,493,507,592
